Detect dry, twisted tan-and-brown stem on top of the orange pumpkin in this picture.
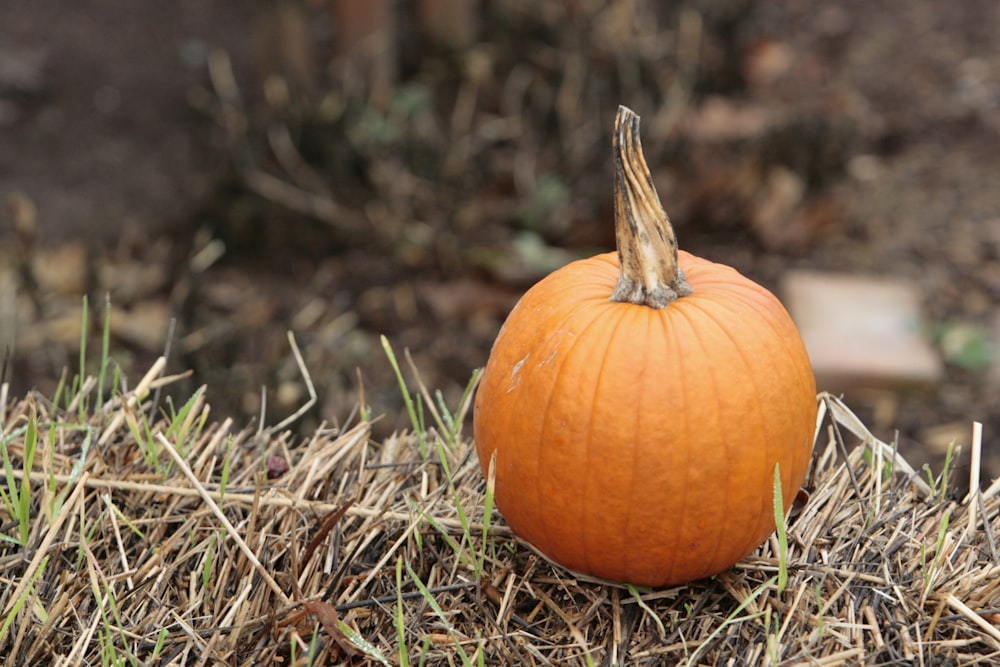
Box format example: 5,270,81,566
611,106,692,308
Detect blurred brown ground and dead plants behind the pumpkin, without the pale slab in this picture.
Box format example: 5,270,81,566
0,0,1000,476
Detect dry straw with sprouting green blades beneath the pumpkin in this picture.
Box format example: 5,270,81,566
0,348,1000,665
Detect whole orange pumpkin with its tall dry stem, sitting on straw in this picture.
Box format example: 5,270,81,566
474,107,817,586
